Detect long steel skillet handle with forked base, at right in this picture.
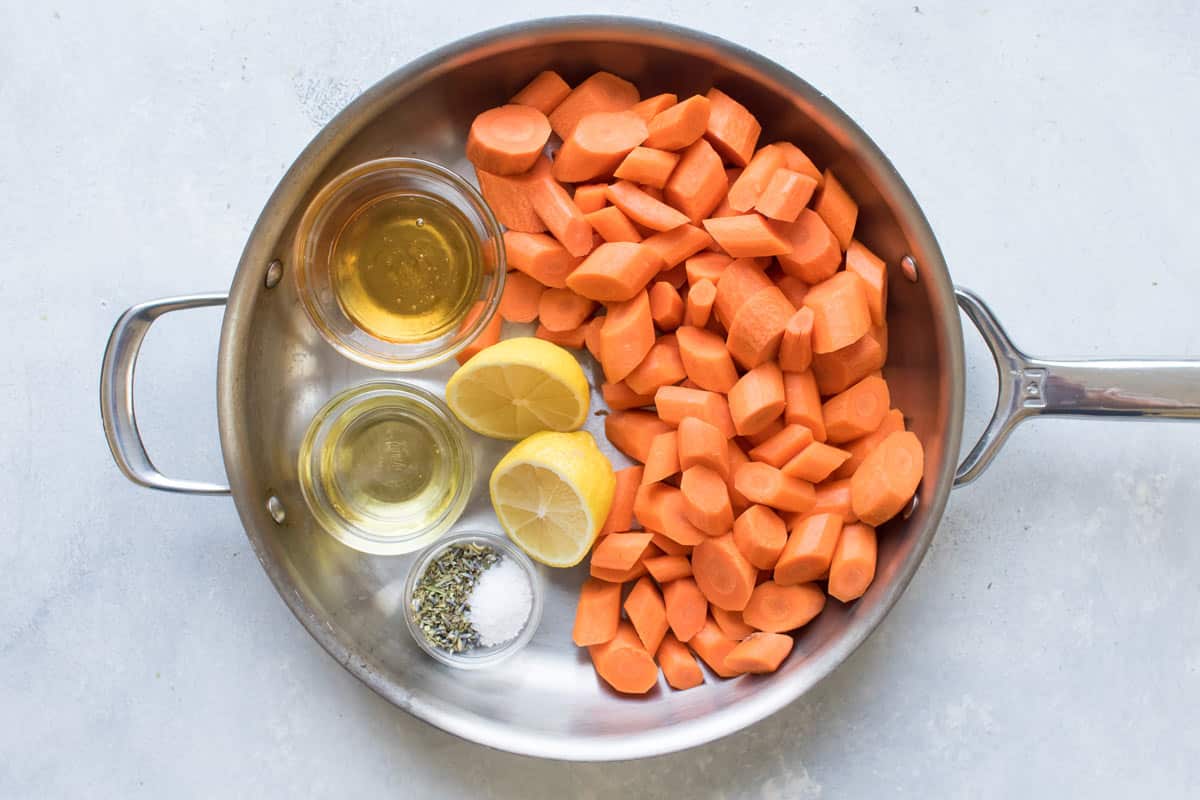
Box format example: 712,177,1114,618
954,288,1200,486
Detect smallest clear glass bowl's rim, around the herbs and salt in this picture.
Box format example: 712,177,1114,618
404,530,545,669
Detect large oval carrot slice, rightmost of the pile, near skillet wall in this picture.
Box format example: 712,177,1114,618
850,431,925,525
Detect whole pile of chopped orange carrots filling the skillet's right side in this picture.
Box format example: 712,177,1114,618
467,72,924,693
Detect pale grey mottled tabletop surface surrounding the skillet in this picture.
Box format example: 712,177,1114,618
0,0,1200,798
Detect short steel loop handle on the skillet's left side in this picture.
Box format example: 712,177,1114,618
100,294,229,494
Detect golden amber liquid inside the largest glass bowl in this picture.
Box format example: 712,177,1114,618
331,193,484,343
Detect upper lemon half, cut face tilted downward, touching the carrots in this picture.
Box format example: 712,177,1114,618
446,337,592,440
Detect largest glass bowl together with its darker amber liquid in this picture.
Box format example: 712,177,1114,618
300,158,506,371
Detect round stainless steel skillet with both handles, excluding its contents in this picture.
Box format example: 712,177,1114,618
101,17,1200,760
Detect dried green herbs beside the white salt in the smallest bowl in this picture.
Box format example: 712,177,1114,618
412,543,500,652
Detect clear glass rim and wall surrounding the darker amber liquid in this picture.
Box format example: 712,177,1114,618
292,158,508,372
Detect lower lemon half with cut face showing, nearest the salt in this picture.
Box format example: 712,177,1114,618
488,431,617,566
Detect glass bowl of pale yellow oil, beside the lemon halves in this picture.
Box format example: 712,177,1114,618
299,380,475,555
